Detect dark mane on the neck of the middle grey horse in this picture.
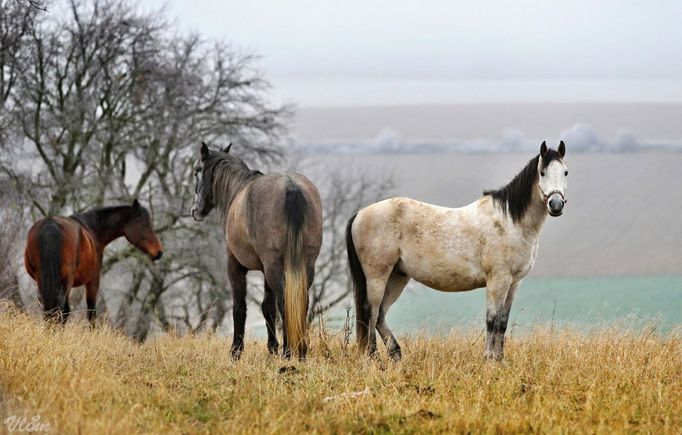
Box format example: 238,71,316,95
204,151,263,220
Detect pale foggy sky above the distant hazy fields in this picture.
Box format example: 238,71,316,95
143,0,682,104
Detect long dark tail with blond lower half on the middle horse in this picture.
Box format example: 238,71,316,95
284,183,308,356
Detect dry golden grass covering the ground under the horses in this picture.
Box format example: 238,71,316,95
0,311,682,433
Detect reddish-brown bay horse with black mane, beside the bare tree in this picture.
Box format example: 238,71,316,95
24,200,163,323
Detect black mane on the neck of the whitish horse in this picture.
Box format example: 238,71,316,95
483,149,561,223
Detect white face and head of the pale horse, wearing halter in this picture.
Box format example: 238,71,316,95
538,141,568,216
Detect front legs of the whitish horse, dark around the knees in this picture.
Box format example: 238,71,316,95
484,276,520,361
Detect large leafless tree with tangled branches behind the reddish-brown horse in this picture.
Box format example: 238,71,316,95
0,0,289,340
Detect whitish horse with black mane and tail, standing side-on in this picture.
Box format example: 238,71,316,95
346,141,568,361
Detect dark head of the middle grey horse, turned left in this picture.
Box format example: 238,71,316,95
191,142,236,222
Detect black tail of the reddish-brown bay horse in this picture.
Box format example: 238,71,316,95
38,219,66,317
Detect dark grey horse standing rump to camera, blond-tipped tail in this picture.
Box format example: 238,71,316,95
191,143,322,359
